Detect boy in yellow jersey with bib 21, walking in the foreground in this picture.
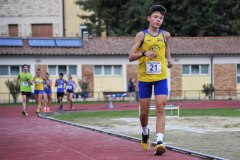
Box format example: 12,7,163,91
129,5,173,155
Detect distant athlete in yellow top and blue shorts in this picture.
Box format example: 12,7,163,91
33,68,44,113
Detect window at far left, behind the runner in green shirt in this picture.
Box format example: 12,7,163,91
0,65,22,76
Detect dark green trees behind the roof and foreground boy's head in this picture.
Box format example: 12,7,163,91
76,0,240,36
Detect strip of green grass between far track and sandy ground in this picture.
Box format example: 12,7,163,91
54,109,240,120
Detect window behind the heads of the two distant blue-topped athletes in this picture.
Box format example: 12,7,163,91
48,65,77,75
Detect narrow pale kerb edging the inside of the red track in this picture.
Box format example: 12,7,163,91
38,112,228,160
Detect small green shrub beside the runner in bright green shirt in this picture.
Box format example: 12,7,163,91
5,79,20,103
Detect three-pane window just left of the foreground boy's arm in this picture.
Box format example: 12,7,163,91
94,65,122,76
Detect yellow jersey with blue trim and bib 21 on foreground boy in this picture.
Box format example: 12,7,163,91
138,29,167,82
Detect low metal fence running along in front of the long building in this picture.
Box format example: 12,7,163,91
0,90,240,103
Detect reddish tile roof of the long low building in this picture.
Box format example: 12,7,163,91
0,36,240,55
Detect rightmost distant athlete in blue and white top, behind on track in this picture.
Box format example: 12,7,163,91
66,74,77,110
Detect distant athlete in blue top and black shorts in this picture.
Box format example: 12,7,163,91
55,73,66,111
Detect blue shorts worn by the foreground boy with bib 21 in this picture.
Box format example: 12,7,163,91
138,79,168,98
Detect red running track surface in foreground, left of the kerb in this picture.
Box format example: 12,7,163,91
0,107,206,160
